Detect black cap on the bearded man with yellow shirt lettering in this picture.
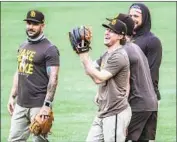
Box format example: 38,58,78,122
23,10,44,23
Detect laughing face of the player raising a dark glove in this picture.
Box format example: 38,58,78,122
104,28,123,47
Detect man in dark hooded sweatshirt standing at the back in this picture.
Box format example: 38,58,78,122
129,3,162,100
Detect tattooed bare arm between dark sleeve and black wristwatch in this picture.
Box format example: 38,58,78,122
45,66,59,102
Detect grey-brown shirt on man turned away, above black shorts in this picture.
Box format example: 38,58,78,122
124,42,158,111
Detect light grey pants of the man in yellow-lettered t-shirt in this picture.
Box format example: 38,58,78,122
8,104,48,142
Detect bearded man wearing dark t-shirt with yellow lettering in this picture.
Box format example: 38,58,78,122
7,10,60,142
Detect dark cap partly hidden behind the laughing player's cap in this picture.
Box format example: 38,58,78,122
106,13,135,36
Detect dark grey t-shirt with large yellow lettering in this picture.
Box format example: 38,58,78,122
17,38,59,108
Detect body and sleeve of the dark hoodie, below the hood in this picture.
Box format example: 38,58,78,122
133,32,162,100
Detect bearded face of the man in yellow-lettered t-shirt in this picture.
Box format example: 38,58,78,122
26,21,44,39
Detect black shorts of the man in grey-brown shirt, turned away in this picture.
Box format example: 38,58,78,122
127,111,157,141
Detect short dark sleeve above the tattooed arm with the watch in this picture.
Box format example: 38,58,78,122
45,46,60,66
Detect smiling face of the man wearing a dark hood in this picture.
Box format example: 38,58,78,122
129,8,142,29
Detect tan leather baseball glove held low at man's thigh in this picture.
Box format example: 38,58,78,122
29,109,54,136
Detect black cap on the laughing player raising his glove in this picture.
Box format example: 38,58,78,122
102,19,127,35
